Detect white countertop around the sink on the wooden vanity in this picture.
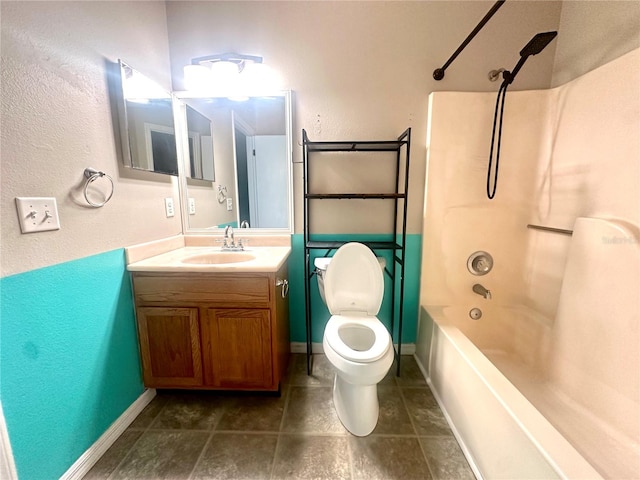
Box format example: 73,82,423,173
127,246,291,273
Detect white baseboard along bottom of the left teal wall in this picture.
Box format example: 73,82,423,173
60,388,156,480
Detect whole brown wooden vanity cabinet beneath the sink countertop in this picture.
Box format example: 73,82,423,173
132,264,289,391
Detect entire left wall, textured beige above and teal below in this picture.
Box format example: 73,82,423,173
0,2,175,479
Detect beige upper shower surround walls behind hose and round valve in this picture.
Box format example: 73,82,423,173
421,49,640,317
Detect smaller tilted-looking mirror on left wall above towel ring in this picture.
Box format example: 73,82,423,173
117,60,178,175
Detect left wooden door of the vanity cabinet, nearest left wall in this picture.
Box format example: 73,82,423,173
137,307,202,387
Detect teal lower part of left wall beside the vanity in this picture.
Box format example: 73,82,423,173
0,249,144,480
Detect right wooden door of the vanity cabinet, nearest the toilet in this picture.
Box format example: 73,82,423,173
200,308,273,389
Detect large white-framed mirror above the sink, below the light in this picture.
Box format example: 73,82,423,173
176,92,293,233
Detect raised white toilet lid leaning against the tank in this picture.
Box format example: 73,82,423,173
324,242,384,316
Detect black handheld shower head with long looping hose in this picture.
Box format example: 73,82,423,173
487,32,558,200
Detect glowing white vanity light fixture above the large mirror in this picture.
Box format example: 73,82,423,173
184,53,280,100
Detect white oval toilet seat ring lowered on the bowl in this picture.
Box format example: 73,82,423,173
324,315,391,363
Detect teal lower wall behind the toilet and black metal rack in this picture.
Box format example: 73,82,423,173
289,234,422,343
